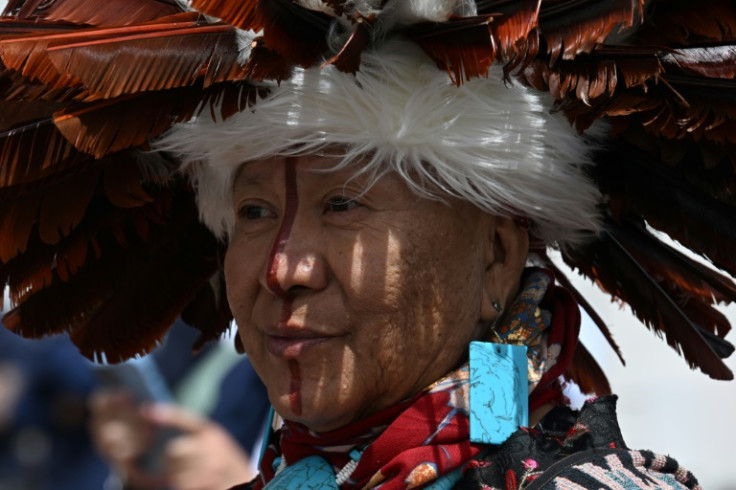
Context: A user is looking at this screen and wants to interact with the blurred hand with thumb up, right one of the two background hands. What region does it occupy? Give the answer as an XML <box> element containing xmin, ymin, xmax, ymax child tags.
<box><xmin>142</xmin><ymin>404</ymin><xmax>256</xmax><ymax>490</ymax></box>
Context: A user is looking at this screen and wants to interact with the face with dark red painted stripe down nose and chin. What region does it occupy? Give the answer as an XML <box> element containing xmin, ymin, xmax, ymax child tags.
<box><xmin>225</xmin><ymin>156</ymin><xmax>494</xmax><ymax>431</ymax></box>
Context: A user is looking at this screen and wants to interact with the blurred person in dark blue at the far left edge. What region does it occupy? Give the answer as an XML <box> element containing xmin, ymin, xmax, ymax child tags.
<box><xmin>0</xmin><ymin>325</ymin><xmax>107</xmax><ymax>490</ymax></box>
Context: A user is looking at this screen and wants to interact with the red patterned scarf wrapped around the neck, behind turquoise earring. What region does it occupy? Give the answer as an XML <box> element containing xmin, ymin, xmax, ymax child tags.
<box><xmin>254</xmin><ymin>268</ymin><xmax>580</xmax><ymax>490</ymax></box>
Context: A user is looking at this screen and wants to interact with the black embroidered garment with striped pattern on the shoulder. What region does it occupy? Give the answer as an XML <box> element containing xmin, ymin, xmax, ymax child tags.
<box><xmin>455</xmin><ymin>395</ymin><xmax>700</xmax><ymax>490</ymax></box>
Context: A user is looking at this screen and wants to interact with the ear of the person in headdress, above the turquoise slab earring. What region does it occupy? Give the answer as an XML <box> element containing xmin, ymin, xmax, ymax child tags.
<box><xmin>480</xmin><ymin>216</ymin><xmax>529</xmax><ymax>323</ymax></box>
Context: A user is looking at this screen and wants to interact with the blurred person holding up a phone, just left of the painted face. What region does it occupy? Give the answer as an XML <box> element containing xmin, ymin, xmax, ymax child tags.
<box><xmin>90</xmin><ymin>322</ymin><xmax>268</xmax><ymax>490</ymax></box>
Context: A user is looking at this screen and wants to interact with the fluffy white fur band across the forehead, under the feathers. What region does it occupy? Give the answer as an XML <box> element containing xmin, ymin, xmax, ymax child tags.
<box><xmin>158</xmin><ymin>39</ymin><xmax>599</xmax><ymax>244</ymax></box>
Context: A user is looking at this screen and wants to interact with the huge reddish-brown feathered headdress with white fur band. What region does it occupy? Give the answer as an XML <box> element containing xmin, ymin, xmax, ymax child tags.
<box><xmin>0</xmin><ymin>0</ymin><xmax>736</xmax><ymax>393</ymax></box>
